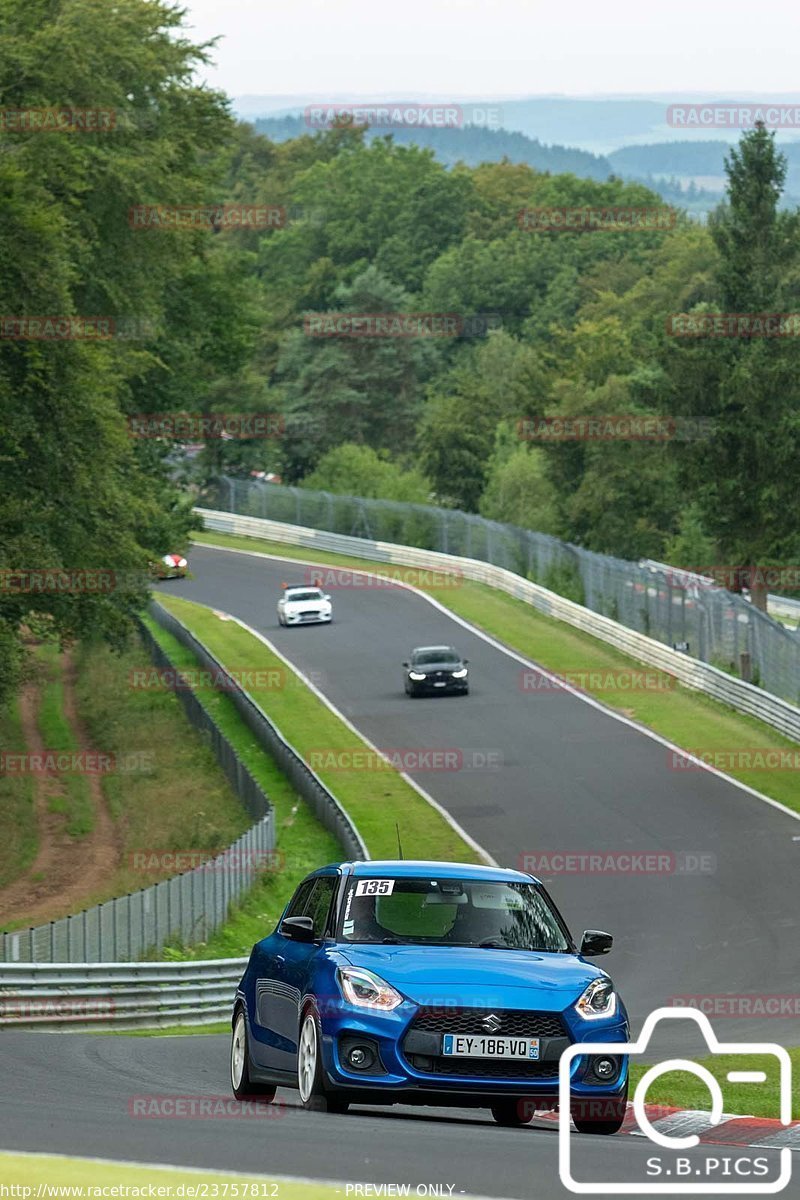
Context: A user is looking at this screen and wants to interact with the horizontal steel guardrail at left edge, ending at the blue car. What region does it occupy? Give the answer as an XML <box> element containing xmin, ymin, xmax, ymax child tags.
<box><xmin>0</xmin><ymin>959</ymin><xmax>247</xmax><ymax>1032</ymax></box>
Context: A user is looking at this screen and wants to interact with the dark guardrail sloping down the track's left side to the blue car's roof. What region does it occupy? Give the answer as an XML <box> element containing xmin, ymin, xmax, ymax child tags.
<box><xmin>150</xmin><ymin>601</ymin><xmax>369</xmax><ymax>859</ymax></box>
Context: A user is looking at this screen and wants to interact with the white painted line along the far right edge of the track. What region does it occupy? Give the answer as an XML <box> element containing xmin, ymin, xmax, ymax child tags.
<box><xmin>193</xmin><ymin>541</ymin><xmax>800</xmax><ymax>821</ymax></box>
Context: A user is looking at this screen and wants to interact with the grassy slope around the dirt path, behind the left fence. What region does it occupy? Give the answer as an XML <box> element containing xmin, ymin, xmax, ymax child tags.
<box><xmin>0</xmin><ymin>636</ymin><xmax>253</xmax><ymax>931</ymax></box>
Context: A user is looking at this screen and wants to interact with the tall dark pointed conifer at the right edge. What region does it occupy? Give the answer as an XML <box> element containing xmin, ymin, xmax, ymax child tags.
<box><xmin>667</xmin><ymin>125</ymin><xmax>800</xmax><ymax>611</ymax></box>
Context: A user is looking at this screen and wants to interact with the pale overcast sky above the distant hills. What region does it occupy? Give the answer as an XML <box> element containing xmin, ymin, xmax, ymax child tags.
<box><xmin>185</xmin><ymin>0</ymin><xmax>800</xmax><ymax>98</ymax></box>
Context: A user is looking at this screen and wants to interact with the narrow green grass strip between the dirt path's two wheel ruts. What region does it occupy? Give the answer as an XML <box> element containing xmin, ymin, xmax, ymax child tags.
<box><xmin>36</xmin><ymin>642</ymin><xmax>95</xmax><ymax>840</ymax></box>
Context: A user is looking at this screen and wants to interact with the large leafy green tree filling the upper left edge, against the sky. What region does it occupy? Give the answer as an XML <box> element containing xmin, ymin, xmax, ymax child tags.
<box><xmin>0</xmin><ymin>0</ymin><xmax>231</xmax><ymax>703</ymax></box>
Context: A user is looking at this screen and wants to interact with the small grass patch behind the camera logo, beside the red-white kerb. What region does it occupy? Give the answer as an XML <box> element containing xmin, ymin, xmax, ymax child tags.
<box><xmin>630</xmin><ymin>1049</ymin><xmax>800</xmax><ymax>1121</ymax></box>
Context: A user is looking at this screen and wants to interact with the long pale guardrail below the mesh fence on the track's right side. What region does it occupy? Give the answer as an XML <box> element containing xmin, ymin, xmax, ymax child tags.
<box><xmin>194</xmin><ymin>508</ymin><xmax>800</xmax><ymax>742</ymax></box>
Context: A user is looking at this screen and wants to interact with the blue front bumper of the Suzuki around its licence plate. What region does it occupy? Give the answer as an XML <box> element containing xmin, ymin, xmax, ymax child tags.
<box><xmin>320</xmin><ymin>1002</ymin><xmax>628</xmax><ymax>1105</ymax></box>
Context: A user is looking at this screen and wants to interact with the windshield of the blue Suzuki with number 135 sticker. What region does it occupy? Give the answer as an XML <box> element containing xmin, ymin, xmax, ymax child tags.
<box><xmin>339</xmin><ymin>877</ymin><xmax>571</xmax><ymax>952</ymax></box>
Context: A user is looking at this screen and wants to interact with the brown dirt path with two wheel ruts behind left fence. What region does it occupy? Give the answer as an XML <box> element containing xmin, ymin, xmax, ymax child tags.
<box><xmin>0</xmin><ymin>653</ymin><xmax>120</xmax><ymax>928</ymax></box>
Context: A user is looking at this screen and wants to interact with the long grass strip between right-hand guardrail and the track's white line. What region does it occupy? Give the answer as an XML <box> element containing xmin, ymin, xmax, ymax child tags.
<box><xmin>194</xmin><ymin>533</ymin><xmax>800</xmax><ymax>812</ymax></box>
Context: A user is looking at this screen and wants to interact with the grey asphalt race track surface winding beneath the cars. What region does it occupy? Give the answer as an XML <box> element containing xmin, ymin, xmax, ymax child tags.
<box><xmin>0</xmin><ymin>546</ymin><xmax>800</xmax><ymax>1200</ymax></box>
